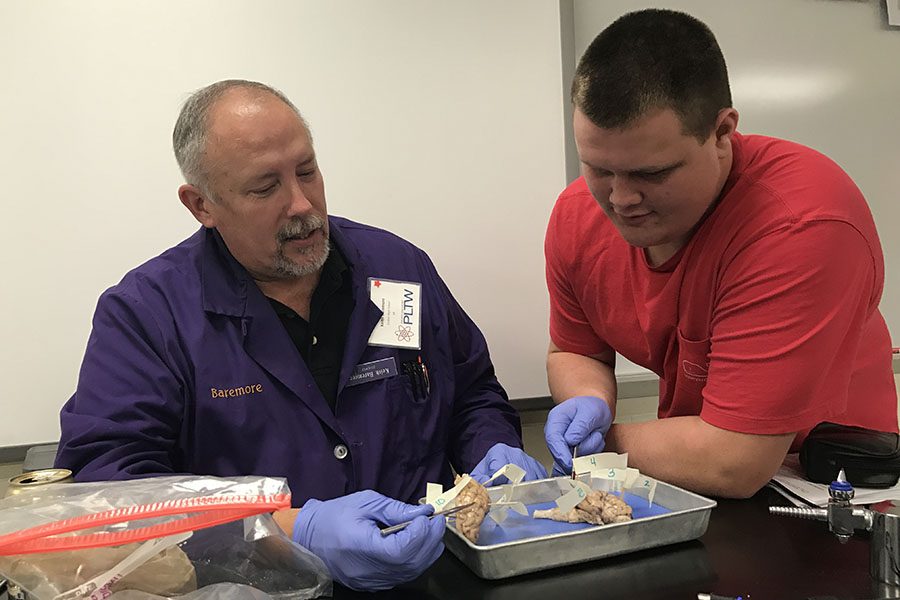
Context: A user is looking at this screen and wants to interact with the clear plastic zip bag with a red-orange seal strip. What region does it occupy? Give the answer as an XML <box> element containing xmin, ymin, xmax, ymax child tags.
<box><xmin>0</xmin><ymin>476</ymin><xmax>331</xmax><ymax>600</ymax></box>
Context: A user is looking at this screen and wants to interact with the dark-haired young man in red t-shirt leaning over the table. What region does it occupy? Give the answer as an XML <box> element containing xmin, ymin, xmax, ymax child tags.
<box><xmin>545</xmin><ymin>9</ymin><xmax>897</xmax><ymax>497</ymax></box>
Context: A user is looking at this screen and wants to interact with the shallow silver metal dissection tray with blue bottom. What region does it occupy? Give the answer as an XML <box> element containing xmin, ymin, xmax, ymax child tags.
<box><xmin>444</xmin><ymin>478</ymin><xmax>716</xmax><ymax>579</ymax></box>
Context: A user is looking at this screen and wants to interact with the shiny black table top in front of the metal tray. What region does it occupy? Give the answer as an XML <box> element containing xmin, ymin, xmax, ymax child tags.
<box><xmin>335</xmin><ymin>488</ymin><xmax>900</xmax><ymax>600</ymax></box>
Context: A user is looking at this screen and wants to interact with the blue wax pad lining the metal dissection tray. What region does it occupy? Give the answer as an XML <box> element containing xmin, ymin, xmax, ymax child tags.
<box><xmin>477</xmin><ymin>492</ymin><xmax>672</xmax><ymax>546</ymax></box>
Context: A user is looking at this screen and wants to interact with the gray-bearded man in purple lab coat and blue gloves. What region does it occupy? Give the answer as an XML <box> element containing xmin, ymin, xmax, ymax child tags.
<box><xmin>56</xmin><ymin>80</ymin><xmax>546</xmax><ymax>589</ymax></box>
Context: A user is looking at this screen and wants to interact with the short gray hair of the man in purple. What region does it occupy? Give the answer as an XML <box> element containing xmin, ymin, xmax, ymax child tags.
<box><xmin>172</xmin><ymin>79</ymin><xmax>312</xmax><ymax>195</ymax></box>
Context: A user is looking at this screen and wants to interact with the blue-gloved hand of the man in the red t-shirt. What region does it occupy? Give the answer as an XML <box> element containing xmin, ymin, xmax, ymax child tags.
<box><xmin>544</xmin><ymin>396</ymin><xmax>612</xmax><ymax>476</ymax></box>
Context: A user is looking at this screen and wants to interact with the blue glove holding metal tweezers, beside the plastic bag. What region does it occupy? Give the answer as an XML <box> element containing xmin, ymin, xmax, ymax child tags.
<box><xmin>293</xmin><ymin>490</ymin><xmax>445</xmax><ymax>591</ymax></box>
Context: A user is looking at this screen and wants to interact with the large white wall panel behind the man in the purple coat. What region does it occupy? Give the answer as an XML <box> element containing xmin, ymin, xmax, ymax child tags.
<box><xmin>0</xmin><ymin>0</ymin><xmax>565</xmax><ymax>446</ymax></box>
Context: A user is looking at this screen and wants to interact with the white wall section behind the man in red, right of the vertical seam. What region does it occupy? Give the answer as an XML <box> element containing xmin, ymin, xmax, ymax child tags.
<box><xmin>574</xmin><ymin>0</ymin><xmax>900</xmax><ymax>346</ymax></box>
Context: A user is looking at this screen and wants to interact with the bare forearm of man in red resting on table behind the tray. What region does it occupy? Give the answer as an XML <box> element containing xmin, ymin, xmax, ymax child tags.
<box><xmin>606</xmin><ymin>416</ymin><xmax>794</xmax><ymax>498</ymax></box>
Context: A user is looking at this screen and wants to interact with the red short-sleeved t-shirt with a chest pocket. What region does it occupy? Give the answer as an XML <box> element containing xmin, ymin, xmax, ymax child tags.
<box><xmin>544</xmin><ymin>135</ymin><xmax>897</xmax><ymax>449</ymax></box>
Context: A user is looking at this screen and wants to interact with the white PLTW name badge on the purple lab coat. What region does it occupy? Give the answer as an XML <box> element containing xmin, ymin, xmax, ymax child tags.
<box><xmin>369</xmin><ymin>277</ymin><xmax>422</xmax><ymax>350</ymax></box>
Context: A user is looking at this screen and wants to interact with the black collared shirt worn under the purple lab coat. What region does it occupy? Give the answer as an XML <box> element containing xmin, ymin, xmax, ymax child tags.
<box><xmin>269</xmin><ymin>244</ymin><xmax>353</xmax><ymax>410</ymax></box>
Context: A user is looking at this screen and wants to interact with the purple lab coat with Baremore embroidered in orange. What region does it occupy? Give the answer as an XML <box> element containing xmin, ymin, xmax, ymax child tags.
<box><xmin>56</xmin><ymin>217</ymin><xmax>522</xmax><ymax>506</ymax></box>
